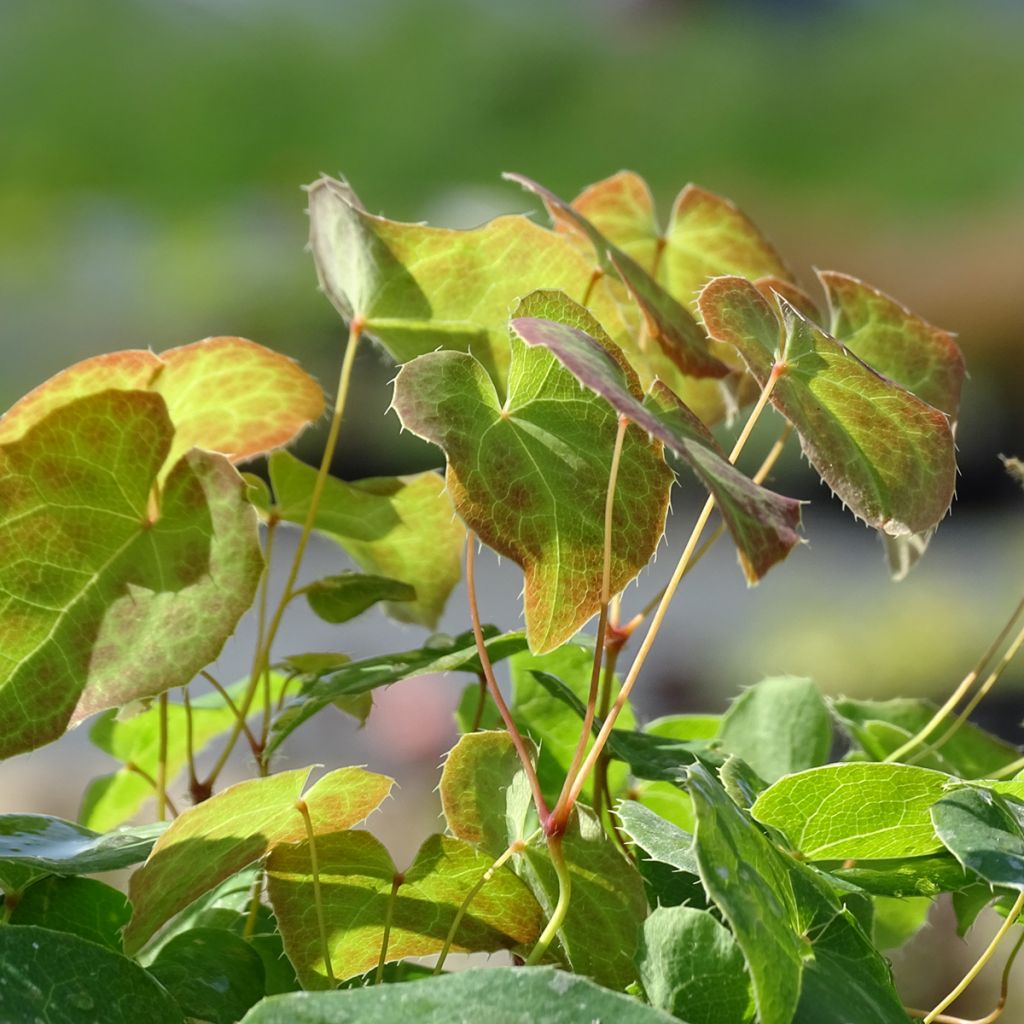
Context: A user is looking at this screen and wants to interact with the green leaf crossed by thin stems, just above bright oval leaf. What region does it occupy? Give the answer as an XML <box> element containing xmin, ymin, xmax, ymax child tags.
<box><xmin>831</xmin><ymin>697</ymin><xmax>1020</xmax><ymax>778</ymax></box>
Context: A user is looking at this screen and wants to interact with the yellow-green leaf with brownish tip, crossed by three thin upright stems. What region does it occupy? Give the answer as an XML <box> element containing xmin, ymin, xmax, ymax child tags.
<box><xmin>267</xmin><ymin>831</ymin><xmax>545</xmax><ymax>989</ymax></box>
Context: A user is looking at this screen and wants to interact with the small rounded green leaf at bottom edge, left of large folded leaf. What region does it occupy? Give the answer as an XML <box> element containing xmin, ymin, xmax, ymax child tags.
<box><xmin>637</xmin><ymin>906</ymin><xmax>751</xmax><ymax>1024</ymax></box>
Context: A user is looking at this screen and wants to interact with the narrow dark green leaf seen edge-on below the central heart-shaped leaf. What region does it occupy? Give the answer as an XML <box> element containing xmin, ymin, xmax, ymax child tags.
<box><xmin>264</xmin><ymin>626</ymin><xmax>526</xmax><ymax>758</ymax></box>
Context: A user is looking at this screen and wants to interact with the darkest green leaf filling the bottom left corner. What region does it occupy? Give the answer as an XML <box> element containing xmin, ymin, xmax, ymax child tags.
<box><xmin>0</xmin><ymin>925</ymin><xmax>183</xmax><ymax>1024</ymax></box>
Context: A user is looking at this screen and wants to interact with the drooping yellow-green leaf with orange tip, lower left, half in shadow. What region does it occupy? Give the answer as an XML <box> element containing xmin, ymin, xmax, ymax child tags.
<box><xmin>124</xmin><ymin>768</ymin><xmax>393</xmax><ymax>953</ymax></box>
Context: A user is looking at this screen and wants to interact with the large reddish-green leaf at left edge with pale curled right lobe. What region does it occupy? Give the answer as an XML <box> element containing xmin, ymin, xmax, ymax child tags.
<box><xmin>0</xmin><ymin>391</ymin><xmax>263</xmax><ymax>757</ymax></box>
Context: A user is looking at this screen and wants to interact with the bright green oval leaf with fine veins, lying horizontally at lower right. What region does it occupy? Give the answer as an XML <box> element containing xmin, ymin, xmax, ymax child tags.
<box><xmin>752</xmin><ymin>762</ymin><xmax>950</xmax><ymax>860</ymax></box>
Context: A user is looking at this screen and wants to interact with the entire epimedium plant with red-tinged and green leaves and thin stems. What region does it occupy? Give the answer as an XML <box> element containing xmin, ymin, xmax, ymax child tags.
<box><xmin>0</xmin><ymin>172</ymin><xmax>1024</xmax><ymax>1024</ymax></box>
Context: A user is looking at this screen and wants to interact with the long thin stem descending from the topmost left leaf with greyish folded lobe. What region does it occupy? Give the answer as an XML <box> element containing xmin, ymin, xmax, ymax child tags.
<box><xmin>205</xmin><ymin>316</ymin><xmax>365</xmax><ymax>787</ymax></box>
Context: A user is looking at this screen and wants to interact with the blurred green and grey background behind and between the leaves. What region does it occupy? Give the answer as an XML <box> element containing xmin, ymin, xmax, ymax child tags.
<box><xmin>0</xmin><ymin>0</ymin><xmax>1024</xmax><ymax>1012</ymax></box>
